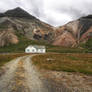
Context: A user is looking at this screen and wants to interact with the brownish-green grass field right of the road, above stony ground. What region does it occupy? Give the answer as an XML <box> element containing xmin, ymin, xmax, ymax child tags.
<box><xmin>32</xmin><ymin>53</ymin><xmax>92</xmax><ymax>75</ymax></box>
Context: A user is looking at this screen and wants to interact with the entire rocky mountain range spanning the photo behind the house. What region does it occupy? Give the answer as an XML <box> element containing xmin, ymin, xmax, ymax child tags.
<box><xmin>0</xmin><ymin>7</ymin><xmax>92</xmax><ymax>47</ymax></box>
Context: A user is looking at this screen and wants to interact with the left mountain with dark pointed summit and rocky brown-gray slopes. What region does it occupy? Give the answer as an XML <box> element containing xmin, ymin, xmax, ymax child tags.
<box><xmin>0</xmin><ymin>7</ymin><xmax>54</xmax><ymax>46</ymax></box>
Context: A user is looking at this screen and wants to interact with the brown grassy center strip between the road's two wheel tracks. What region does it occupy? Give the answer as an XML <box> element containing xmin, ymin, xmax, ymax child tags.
<box><xmin>11</xmin><ymin>59</ymin><xmax>30</xmax><ymax>92</ymax></box>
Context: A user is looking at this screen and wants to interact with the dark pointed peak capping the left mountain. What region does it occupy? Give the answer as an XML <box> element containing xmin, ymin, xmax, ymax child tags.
<box><xmin>0</xmin><ymin>7</ymin><xmax>35</xmax><ymax>19</ymax></box>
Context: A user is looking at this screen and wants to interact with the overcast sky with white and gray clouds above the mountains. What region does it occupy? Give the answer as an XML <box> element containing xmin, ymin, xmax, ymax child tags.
<box><xmin>0</xmin><ymin>0</ymin><xmax>92</xmax><ymax>26</ymax></box>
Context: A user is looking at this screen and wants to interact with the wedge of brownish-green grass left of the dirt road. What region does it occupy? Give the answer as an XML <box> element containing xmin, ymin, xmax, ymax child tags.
<box><xmin>0</xmin><ymin>53</ymin><xmax>27</xmax><ymax>67</ymax></box>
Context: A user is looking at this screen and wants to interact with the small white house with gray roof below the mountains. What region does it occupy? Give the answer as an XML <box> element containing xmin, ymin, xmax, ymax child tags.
<box><xmin>25</xmin><ymin>45</ymin><xmax>46</xmax><ymax>53</ymax></box>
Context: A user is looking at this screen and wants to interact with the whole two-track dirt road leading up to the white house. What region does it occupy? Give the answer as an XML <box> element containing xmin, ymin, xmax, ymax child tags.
<box><xmin>0</xmin><ymin>56</ymin><xmax>71</xmax><ymax>92</ymax></box>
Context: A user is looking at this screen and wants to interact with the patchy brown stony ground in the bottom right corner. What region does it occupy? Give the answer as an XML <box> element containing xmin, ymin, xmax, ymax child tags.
<box><xmin>41</xmin><ymin>70</ymin><xmax>92</xmax><ymax>92</ymax></box>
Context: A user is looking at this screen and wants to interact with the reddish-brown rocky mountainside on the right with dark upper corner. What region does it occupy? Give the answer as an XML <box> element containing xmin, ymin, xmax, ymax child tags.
<box><xmin>53</xmin><ymin>15</ymin><xmax>92</xmax><ymax>47</ymax></box>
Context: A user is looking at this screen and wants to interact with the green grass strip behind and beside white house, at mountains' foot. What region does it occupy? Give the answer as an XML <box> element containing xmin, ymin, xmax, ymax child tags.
<box><xmin>0</xmin><ymin>35</ymin><xmax>86</xmax><ymax>53</ymax></box>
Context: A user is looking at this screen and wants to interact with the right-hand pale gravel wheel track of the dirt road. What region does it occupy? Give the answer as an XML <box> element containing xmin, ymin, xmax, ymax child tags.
<box><xmin>24</xmin><ymin>57</ymin><xmax>48</xmax><ymax>92</ymax></box>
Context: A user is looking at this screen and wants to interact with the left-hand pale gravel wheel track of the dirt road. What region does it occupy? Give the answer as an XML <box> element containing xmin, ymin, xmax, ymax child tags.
<box><xmin>0</xmin><ymin>58</ymin><xmax>21</xmax><ymax>92</ymax></box>
